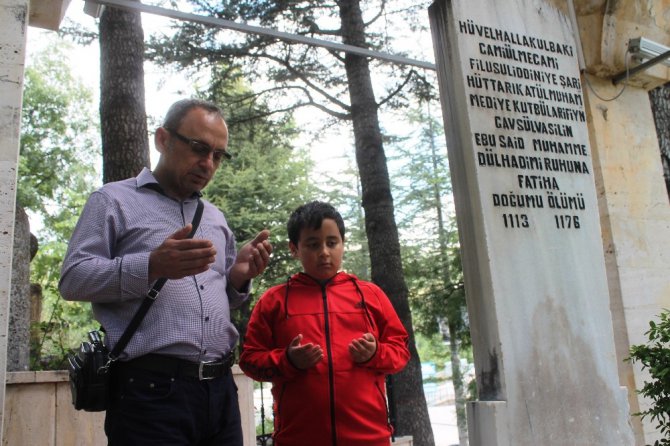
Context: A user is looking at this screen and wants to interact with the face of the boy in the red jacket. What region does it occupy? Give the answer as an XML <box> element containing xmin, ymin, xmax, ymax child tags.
<box><xmin>289</xmin><ymin>218</ymin><xmax>344</xmax><ymax>280</ymax></box>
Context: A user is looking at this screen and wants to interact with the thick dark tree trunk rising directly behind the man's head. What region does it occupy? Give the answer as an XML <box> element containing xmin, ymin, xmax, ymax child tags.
<box><xmin>100</xmin><ymin>2</ymin><xmax>150</xmax><ymax>183</ymax></box>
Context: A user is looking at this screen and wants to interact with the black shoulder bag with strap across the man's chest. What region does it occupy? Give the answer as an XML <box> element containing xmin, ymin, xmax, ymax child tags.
<box><xmin>67</xmin><ymin>200</ymin><xmax>204</xmax><ymax>412</ymax></box>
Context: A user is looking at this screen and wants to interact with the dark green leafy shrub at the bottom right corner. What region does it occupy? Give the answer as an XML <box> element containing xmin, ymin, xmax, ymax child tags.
<box><xmin>628</xmin><ymin>310</ymin><xmax>670</xmax><ymax>446</ymax></box>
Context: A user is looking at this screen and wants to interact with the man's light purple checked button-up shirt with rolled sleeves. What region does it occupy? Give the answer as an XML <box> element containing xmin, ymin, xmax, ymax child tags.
<box><xmin>59</xmin><ymin>168</ymin><xmax>248</xmax><ymax>361</ymax></box>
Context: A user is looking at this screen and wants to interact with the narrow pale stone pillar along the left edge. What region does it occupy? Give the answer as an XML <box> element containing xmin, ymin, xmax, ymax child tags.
<box><xmin>0</xmin><ymin>0</ymin><xmax>28</xmax><ymax>443</ymax></box>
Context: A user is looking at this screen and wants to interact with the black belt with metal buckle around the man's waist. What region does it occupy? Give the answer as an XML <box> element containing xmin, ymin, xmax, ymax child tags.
<box><xmin>116</xmin><ymin>352</ymin><xmax>235</xmax><ymax>380</ymax></box>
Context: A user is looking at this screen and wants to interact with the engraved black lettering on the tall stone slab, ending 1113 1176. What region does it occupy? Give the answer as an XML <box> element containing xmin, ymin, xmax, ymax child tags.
<box><xmin>458</xmin><ymin>19</ymin><xmax>593</xmax><ymax>231</ymax></box>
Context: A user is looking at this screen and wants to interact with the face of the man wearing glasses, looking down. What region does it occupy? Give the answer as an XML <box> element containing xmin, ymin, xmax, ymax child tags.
<box><xmin>154</xmin><ymin>108</ymin><xmax>228</xmax><ymax>200</ymax></box>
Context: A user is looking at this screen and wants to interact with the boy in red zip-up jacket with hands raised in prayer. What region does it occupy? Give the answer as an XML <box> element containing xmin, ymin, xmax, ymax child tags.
<box><xmin>240</xmin><ymin>201</ymin><xmax>409</xmax><ymax>446</ymax></box>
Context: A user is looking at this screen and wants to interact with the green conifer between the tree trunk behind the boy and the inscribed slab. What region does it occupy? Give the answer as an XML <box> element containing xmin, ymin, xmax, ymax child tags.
<box><xmin>393</xmin><ymin>104</ymin><xmax>471</xmax><ymax>444</ymax></box>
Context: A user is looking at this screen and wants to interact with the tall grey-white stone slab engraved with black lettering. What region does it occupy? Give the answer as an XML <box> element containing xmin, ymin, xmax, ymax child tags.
<box><xmin>430</xmin><ymin>0</ymin><xmax>634</xmax><ymax>446</ymax></box>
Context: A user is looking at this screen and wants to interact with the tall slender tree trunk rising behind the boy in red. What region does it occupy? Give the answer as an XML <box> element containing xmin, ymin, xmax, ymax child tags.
<box><xmin>339</xmin><ymin>0</ymin><xmax>435</xmax><ymax>446</ymax></box>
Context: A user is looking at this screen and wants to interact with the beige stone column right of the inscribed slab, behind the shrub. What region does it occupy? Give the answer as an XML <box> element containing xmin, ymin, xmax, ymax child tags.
<box><xmin>586</xmin><ymin>76</ymin><xmax>670</xmax><ymax>445</ymax></box>
